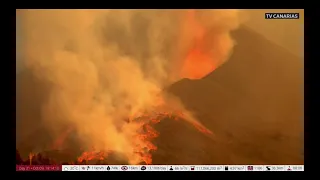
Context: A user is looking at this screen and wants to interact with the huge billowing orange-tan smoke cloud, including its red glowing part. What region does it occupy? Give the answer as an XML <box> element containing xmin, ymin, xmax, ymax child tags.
<box><xmin>17</xmin><ymin>10</ymin><xmax>244</xmax><ymax>163</ymax></box>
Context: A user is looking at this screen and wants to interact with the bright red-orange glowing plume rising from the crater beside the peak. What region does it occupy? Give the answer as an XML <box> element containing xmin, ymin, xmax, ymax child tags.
<box><xmin>180</xmin><ymin>10</ymin><xmax>240</xmax><ymax>79</ymax></box>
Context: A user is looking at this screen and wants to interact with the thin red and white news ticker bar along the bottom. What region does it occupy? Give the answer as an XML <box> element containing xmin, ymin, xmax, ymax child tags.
<box><xmin>16</xmin><ymin>165</ymin><xmax>304</xmax><ymax>171</ymax></box>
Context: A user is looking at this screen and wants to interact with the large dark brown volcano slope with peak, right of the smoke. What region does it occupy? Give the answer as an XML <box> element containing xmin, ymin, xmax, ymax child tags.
<box><xmin>164</xmin><ymin>27</ymin><xmax>303</xmax><ymax>164</ymax></box>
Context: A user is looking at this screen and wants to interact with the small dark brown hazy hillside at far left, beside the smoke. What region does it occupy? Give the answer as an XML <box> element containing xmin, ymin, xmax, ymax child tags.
<box><xmin>16</xmin><ymin>69</ymin><xmax>49</xmax><ymax>158</ymax></box>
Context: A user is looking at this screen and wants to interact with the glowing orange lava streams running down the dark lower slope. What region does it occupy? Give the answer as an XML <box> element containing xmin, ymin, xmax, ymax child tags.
<box><xmin>20</xmin><ymin>107</ymin><xmax>212</xmax><ymax>164</ymax></box>
